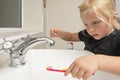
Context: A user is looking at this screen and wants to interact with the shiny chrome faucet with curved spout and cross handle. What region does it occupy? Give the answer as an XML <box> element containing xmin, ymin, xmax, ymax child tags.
<box><xmin>3</xmin><ymin>37</ymin><xmax>55</xmax><ymax>67</ymax></box>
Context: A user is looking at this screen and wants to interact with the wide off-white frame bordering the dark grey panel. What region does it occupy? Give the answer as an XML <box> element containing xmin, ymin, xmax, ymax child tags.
<box><xmin>0</xmin><ymin>0</ymin><xmax>43</xmax><ymax>32</ymax></box>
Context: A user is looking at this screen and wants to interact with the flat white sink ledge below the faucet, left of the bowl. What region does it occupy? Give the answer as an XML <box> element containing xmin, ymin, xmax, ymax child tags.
<box><xmin>0</xmin><ymin>64</ymin><xmax>34</xmax><ymax>80</ymax></box>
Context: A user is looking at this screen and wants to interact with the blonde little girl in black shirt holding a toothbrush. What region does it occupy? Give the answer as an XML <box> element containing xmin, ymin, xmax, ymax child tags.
<box><xmin>50</xmin><ymin>0</ymin><xmax>120</xmax><ymax>80</ymax></box>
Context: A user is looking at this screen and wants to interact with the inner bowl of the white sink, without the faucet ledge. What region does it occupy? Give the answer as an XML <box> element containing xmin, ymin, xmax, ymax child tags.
<box><xmin>26</xmin><ymin>49</ymin><xmax>84</xmax><ymax>80</ymax></box>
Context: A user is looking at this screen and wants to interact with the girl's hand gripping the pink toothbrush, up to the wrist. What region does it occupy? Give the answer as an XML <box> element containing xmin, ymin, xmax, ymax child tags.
<box><xmin>65</xmin><ymin>55</ymin><xmax>98</xmax><ymax>80</ymax></box>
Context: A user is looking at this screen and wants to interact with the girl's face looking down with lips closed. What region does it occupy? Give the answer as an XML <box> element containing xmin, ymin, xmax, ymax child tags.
<box><xmin>81</xmin><ymin>10</ymin><xmax>113</xmax><ymax>40</ymax></box>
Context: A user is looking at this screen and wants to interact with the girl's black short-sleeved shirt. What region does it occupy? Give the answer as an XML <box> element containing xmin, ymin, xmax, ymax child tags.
<box><xmin>78</xmin><ymin>30</ymin><xmax>120</xmax><ymax>56</ymax></box>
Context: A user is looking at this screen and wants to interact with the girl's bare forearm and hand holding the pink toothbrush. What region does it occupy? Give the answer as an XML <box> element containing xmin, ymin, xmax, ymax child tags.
<box><xmin>65</xmin><ymin>55</ymin><xmax>120</xmax><ymax>80</ymax></box>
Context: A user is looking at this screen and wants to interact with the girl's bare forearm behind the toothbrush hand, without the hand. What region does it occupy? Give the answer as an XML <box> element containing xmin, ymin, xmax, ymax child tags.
<box><xmin>96</xmin><ymin>55</ymin><xmax>120</xmax><ymax>75</ymax></box>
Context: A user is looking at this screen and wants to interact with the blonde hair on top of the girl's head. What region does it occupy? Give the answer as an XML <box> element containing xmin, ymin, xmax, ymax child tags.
<box><xmin>78</xmin><ymin>0</ymin><xmax>116</xmax><ymax>24</ymax></box>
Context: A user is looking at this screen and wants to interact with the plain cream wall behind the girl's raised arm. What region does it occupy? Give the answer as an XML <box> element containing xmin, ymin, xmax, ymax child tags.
<box><xmin>46</xmin><ymin>0</ymin><xmax>84</xmax><ymax>49</ymax></box>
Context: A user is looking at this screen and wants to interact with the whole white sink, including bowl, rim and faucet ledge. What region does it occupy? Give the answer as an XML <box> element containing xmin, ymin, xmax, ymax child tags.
<box><xmin>0</xmin><ymin>49</ymin><xmax>120</xmax><ymax>80</ymax></box>
